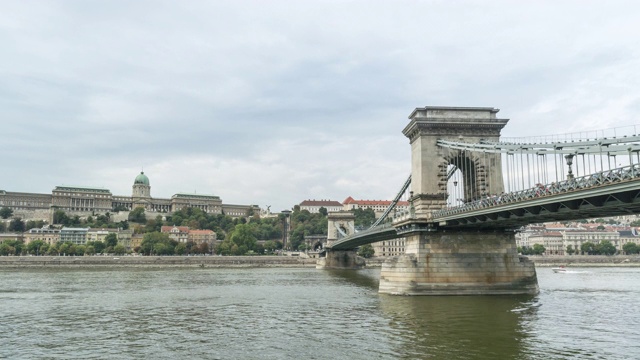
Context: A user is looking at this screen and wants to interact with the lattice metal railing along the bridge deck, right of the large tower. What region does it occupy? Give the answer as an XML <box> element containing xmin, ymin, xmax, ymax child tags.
<box><xmin>432</xmin><ymin>164</ymin><xmax>640</xmax><ymax>218</ymax></box>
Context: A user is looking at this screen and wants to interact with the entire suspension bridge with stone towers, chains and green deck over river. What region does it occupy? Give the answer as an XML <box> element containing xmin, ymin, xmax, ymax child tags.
<box><xmin>320</xmin><ymin>106</ymin><xmax>640</xmax><ymax>295</ymax></box>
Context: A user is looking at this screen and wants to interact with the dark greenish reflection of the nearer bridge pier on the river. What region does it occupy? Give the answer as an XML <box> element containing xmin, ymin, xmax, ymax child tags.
<box><xmin>380</xmin><ymin>295</ymin><xmax>536</xmax><ymax>359</ymax></box>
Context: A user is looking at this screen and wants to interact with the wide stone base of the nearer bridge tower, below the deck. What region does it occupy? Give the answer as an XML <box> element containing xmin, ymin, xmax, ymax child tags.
<box><xmin>379</xmin><ymin>231</ymin><xmax>538</xmax><ymax>295</ymax></box>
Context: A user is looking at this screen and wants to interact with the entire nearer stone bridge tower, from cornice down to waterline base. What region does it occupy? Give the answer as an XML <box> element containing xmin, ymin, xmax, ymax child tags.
<box><xmin>380</xmin><ymin>107</ymin><xmax>538</xmax><ymax>295</ymax></box>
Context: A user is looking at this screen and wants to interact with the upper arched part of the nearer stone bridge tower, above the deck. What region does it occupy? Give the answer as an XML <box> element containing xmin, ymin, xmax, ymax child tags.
<box><xmin>402</xmin><ymin>106</ymin><xmax>509</xmax><ymax>220</ymax></box>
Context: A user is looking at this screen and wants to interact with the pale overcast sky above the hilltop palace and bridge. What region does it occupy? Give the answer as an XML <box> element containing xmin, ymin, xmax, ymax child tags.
<box><xmin>0</xmin><ymin>0</ymin><xmax>640</xmax><ymax>211</ymax></box>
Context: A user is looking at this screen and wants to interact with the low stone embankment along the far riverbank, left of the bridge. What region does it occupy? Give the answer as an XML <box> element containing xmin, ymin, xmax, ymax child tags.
<box><xmin>0</xmin><ymin>256</ymin><xmax>316</xmax><ymax>268</ymax></box>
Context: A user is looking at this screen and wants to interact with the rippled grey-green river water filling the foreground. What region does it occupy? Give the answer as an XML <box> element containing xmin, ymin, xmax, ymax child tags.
<box><xmin>0</xmin><ymin>268</ymin><xmax>640</xmax><ymax>360</ymax></box>
